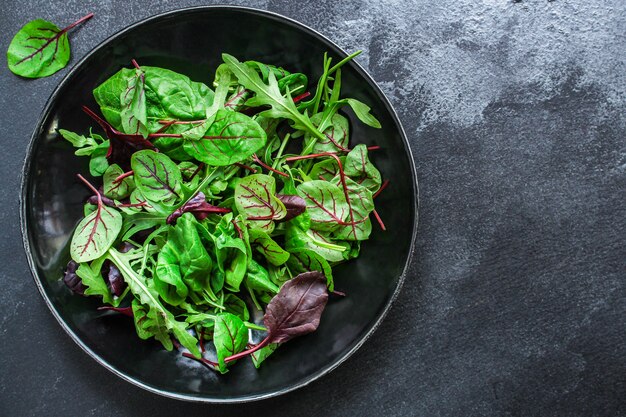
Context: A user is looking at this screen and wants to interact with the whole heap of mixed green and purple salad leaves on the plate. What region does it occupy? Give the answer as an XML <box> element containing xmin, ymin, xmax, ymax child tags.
<box><xmin>59</xmin><ymin>53</ymin><xmax>387</xmax><ymax>373</ymax></box>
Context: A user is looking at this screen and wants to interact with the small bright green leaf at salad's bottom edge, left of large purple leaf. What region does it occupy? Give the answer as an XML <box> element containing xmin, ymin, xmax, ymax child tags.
<box><xmin>213</xmin><ymin>313</ymin><xmax>248</xmax><ymax>373</ymax></box>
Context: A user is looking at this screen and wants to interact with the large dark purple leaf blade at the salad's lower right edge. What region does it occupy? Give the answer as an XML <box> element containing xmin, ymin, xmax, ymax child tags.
<box><xmin>263</xmin><ymin>271</ymin><xmax>328</xmax><ymax>343</ymax></box>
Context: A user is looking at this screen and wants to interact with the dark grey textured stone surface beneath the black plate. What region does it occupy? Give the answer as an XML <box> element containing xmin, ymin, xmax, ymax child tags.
<box><xmin>0</xmin><ymin>0</ymin><xmax>626</xmax><ymax>416</ymax></box>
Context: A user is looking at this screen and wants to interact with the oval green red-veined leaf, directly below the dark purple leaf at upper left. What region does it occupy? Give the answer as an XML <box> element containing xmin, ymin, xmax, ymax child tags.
<box><xmin>130</xmin><ymin>149</ymin><xmax>183</xmax><ymax>203</ymax></box>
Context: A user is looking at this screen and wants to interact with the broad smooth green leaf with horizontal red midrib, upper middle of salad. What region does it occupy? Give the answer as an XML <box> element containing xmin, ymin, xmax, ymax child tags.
<box><xmin>184</xmin><ymin>109</ymin><xmax>267</xmax><ymax>166</ymax></box>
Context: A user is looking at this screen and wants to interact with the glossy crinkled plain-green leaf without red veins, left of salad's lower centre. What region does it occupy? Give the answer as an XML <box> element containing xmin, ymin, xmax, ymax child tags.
<box><xmin>154</xmin><ymin>213</ymin><xmax>212</xmax><ymax>305</ymax></box>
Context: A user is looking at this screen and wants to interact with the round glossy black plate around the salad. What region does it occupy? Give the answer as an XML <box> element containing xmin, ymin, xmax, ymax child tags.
<box><xmin>21</xmin><ymin>7</ymin><xmax>417</xmax><ymax>402</ymax></box>
